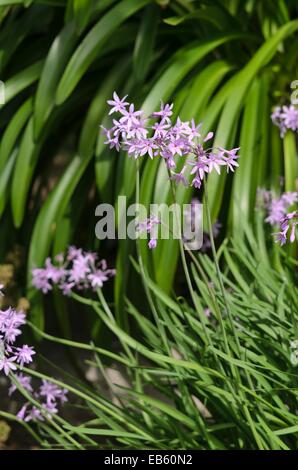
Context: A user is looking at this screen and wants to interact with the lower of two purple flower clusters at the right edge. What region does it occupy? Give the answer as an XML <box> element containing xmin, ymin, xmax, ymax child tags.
<box><xmin>258</xmin><ymin>189</ymin><xmax>298</xmax><ymax>245</ymax></box>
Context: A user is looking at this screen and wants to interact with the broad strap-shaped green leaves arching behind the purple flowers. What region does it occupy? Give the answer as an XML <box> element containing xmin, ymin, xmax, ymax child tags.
<box><xmin>0</xmin><ymin>0</ymin><xmax>298</xmax><ymax>326</ymax></box>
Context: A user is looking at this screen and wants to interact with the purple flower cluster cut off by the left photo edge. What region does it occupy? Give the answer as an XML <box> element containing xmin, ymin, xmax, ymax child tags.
<box><xmin>0</xmin><ymin>307</ymin><xmax>35</xmax><ymax>375</ymax></box>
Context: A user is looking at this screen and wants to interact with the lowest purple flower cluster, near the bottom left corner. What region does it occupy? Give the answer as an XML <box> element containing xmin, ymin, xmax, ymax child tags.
<box><xmin>8</xmin><ymin>373</ymin><xmax>67</xmax><ymax>422</ymax></box>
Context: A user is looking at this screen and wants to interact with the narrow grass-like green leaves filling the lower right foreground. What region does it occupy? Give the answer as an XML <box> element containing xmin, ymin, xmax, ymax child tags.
<box><xmin>9</xmin><ymin>222</ymin><xmax>298</xmax><ymax>450</ymax></box>
